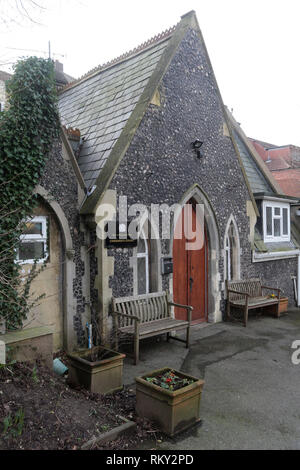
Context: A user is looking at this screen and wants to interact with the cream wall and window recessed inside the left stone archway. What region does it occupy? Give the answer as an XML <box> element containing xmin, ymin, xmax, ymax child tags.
<box><xmin>18</xmin><ymin>197</ymin><xmax>63</xmax><ymax>351</ymax></box>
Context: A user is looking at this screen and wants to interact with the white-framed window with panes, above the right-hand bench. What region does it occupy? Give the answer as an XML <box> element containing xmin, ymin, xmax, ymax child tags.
<box><xmin>263</xmin><ymin>201</ymin><xmax>291</xmax><ymax>242</ymax></box>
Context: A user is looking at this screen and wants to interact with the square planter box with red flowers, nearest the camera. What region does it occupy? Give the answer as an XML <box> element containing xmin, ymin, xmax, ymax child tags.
<box><xmin>135</xmin><ymin>367</ymin><xmax>204</xmax><ymax>436</ymax></box>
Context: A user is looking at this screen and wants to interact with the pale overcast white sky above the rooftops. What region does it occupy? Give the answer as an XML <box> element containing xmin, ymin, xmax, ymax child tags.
<box><xmin>0</xmin><ymin>0</ymin><xmax>300</xmax><ymax>146</ymax></box>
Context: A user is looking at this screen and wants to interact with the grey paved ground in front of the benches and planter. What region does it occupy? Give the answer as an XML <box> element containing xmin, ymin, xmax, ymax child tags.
<box><xmin>124</xmin><ymin>309</ymin><xmax>300</xmax><ymax>450</ymax></box>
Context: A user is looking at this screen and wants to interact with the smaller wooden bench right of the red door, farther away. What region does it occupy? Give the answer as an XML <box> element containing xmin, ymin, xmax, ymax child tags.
<box><xmin>226</xmin><ymin>278</ymin><xmax>280</xmax><ymax>326</ymax></box>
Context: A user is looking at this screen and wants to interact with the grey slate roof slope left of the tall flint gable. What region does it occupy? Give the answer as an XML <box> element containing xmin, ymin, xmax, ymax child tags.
<box><xmin>59</xmin><ymin>28</ymin><xmax>174</xmax><ymax>187</ymax></box>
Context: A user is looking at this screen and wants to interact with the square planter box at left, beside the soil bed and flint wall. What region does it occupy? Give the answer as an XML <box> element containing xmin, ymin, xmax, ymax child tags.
<box><xmin>67</xmin><ymin>346</ymin><xmax>125</xmax><ymax>394</ymax></box>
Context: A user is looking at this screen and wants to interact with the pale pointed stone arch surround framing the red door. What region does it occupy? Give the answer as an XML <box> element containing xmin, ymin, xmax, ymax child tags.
<box><xmin>169</xmin><ymin>184</ymin><xmax>222</xmax><ymax>322</ymax></box>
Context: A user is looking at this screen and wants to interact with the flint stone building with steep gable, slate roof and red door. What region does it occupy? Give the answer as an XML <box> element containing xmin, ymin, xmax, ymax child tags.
<box><xmin>14</xmin><ymin>12</ymin><xmax>300</xmax><ymax>349</ymax></box>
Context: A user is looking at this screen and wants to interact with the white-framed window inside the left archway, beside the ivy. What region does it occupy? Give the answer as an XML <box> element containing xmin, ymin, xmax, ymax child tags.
<box><xmin>17</xmin><ymin>215</ymin><xmax>48</xmax><ymax>264</ymax></box>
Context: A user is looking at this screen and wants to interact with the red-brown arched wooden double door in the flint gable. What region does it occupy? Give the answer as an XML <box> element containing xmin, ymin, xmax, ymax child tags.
<box><xmin>173</xmin><ymin>201</ymin><xmax>208</xmax><ymax>322</ymax></box>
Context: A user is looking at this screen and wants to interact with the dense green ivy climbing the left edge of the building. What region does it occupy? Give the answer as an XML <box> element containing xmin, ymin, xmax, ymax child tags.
<box><xmin>0</xmin><ymin>57</ymin><xmax>59</xmax><ymax>327</ymax></box>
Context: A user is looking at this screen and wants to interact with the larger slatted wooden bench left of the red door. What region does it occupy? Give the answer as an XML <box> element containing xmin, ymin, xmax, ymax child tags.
<box><xmin>112</xmin><ymin>292</ymin><xmax>193</xmax><ymax>364</ymax></box>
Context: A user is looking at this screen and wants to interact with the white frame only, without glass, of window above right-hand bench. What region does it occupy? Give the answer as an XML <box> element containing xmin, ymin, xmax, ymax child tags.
<box><xmin>263</xmin><ymin>201</ymin><xmax>291</xmax><ymax>242</ymax></box>
